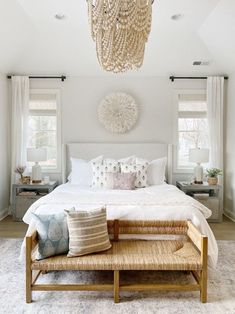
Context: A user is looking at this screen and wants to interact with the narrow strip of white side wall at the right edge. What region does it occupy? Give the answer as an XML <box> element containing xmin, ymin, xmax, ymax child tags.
<box><xmin>224</xmin><ymin>73</ymin><xmax>235</xmax><ymax>220</ymax></box>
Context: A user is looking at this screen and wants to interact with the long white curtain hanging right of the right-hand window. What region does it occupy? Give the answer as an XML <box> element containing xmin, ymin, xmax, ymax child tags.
<box><xmin>207</xmin><ymin>76</ymin><xmax>224</xmax><ymax>170</ymax></box>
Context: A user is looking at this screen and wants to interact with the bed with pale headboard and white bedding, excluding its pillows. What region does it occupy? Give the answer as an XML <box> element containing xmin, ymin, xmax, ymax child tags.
<box><xmin>23</xmin><ymin>143</ymin><xmax>218</xmax><ymax>268</ymax></box>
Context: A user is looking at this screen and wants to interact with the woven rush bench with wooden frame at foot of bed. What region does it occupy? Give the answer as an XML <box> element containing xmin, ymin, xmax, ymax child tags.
<box><xmin>26</xmin><ymin>220</ymin><xmax>208</xmax><ymax>303</ymax></box>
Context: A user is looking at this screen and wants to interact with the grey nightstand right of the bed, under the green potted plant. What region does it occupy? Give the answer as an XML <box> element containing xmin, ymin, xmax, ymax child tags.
<box><xmin>176</xmin><ymin>181</ymin><xmax>223</xmax><ymax>222</ymax></box>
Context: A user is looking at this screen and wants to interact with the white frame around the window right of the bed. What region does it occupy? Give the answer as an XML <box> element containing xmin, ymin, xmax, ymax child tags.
<box><xmin>173</xmin><ymin>89</ymin><xmax>206</xmax><ymax>174</ymax></box>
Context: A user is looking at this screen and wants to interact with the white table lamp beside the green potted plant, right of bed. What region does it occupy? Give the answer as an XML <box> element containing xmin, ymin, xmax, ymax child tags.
<box><xmin>189</xmin><ymin>148</ymin><xmax>209</xmax><ymax>184</ymax></box>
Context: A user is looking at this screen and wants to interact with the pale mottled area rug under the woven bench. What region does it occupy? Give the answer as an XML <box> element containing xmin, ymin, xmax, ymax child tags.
<box><xmin>0</xmin><ymin>239</ymin><xmax>235</xmax><ymax>314</ymax></box>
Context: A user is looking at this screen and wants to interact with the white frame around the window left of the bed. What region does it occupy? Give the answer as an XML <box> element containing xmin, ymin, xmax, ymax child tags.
<box><xmin>29</xmin><ymin>88</ymin><xmax>62</xmax><ymax>174</ymax></box>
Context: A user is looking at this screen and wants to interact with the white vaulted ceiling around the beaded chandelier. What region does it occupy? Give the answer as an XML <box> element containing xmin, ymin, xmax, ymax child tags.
<box><xmin>0</xmin><ymin>0</ymin><xmax>235</xmax><ymax>76</ymax></box>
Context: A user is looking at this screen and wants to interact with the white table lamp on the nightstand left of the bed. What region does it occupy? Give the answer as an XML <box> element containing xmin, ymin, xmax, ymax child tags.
<box><xmin>27</xmin><ymin>148</ymin><xmax>47</xmax><ymax>183</ymax></box>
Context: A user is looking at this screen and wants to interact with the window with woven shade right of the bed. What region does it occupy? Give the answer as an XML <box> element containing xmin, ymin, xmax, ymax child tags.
<box><xmin>175</xmin><ymin>92</ymin><xmax>209</xmax><ymax>170</ymax></box>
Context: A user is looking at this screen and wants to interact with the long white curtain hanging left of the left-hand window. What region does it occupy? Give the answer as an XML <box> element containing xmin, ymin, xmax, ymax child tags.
<box><xmin>11</xmin><ymin>76</ymin><xmax>29</xmax><ymax>184</ymax></box>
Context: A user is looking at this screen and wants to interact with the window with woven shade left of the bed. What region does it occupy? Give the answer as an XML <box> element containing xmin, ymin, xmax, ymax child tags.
<box><xmin>28</xmin><ymin>90</ymin><xmax>61</xmax><ymax>172</ymax></box>
